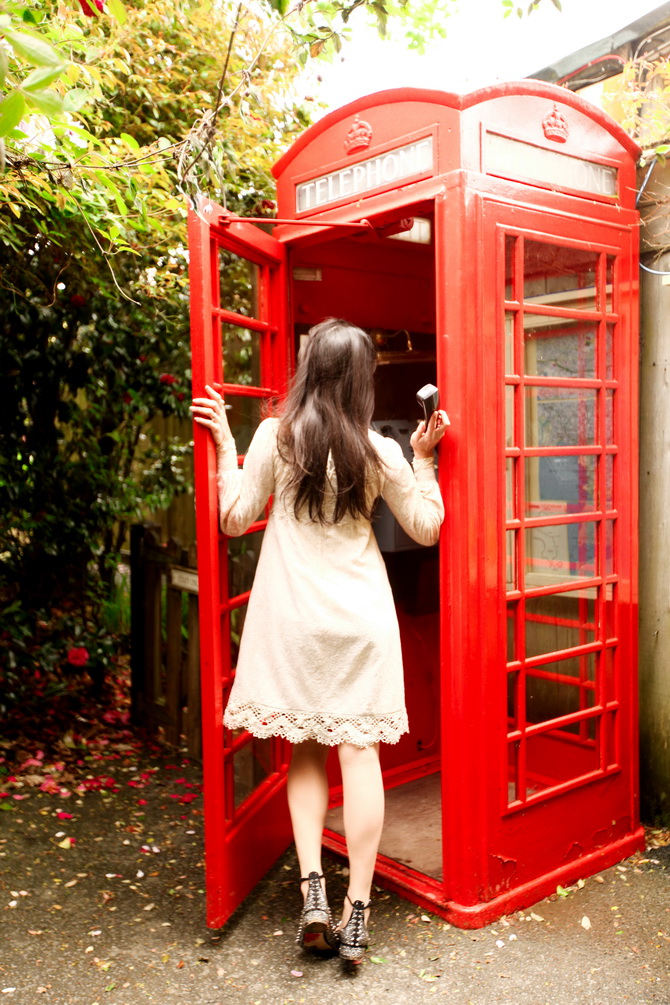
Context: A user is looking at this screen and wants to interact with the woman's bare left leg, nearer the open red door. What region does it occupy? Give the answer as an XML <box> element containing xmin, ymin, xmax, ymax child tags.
<box><xmin>287</xmin><ymin>740</ymin><xmax>330</xmax><ymax>897</ymax></box>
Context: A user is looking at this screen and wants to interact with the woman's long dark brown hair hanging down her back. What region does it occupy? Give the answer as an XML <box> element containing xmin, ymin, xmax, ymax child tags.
<box><xmin>278</xmin><ymin>318</ymin><xmax>382</xmax><ymax>524</ymax></box>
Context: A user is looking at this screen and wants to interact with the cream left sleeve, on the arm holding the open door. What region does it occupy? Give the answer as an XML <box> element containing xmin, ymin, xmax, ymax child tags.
<box><xmin>217</xmin><ymin>419</ymin><xmax>276</xmax><ymax>538</ymax></box>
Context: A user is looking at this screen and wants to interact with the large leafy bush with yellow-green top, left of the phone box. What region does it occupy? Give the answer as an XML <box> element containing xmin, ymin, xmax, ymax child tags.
<box><xmin>0</xmin><ymin>0</ymin><xmax>306</xmax><ymax>635</ymax></box>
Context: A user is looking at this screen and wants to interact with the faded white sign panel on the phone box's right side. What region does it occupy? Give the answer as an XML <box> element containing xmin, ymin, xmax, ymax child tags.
<box><xmin>484</xmin><ymin>133</ymin><xmax>618</xmax><ymax>196</ymax></box>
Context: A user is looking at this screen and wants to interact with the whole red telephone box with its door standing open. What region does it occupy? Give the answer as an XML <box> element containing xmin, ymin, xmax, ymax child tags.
<box><xmin>191</xmin><ymin>81</ymin><xmax>643</xmax><ymax>928</ymax></box>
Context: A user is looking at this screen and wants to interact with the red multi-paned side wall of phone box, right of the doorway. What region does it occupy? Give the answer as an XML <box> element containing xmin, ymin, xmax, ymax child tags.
<box><xmin>476</xmin><ymin>195</ymin><xmax>639</xmax><ymax>904</ymax></box>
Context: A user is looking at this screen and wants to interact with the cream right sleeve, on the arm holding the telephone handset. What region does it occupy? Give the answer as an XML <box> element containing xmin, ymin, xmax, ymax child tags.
<box><xmin>382</xmin><ymin>438</ymin><xmax>444</xmax><ymax>545</ymax></box>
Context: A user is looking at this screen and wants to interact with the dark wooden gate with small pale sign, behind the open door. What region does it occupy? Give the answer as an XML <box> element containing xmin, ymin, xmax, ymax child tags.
<box><xmin>131</xmin><ymin>524</ymin><xmax>202</xmax><ymax>758</ymax></box>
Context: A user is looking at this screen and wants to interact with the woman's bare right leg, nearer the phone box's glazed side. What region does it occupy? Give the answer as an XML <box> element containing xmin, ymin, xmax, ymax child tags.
<box><xmin>338</xmin><ymin>744</ymin><xmax>384</xmax><ymax>925</ymax></box>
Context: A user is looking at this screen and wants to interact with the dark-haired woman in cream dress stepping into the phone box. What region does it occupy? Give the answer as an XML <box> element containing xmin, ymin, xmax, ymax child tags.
<box><xmin>192</xmin><ymin>319</ymin><xmax>446</xmax><ymax>962</ymax></box>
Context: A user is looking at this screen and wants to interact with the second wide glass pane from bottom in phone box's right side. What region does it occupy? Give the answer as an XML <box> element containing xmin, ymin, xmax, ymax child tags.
<box><xmin>525</xmin><ymin>653</ymin><xmax>595</xmax><ymax>734</ymax></box>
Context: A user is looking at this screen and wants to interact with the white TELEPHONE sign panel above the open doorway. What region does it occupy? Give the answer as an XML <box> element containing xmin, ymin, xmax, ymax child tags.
<box><xmin>295</xmin><ymin>136</ymin><xmax>433</xmax><ymax>213</ymax></box>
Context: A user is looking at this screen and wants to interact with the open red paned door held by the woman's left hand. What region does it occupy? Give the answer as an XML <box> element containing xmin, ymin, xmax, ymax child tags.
<box><xmin>189</xmin><ymin>200</ymin><xmax>290</xmax><ymax>928</ymax></box>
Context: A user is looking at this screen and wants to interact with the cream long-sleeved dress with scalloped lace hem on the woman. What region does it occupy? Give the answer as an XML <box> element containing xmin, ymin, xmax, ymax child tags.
<box><xmin>218</xmin><ymin>418</ymin><xmax>444</xmax><ymax>747</ymax></box>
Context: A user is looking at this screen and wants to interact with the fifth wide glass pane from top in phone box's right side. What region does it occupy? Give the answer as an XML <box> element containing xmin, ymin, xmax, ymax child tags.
<box><xmin>525</xmin><ymin>523</ymin><xmax>597</xmax><ymax>587</ymax></box>
